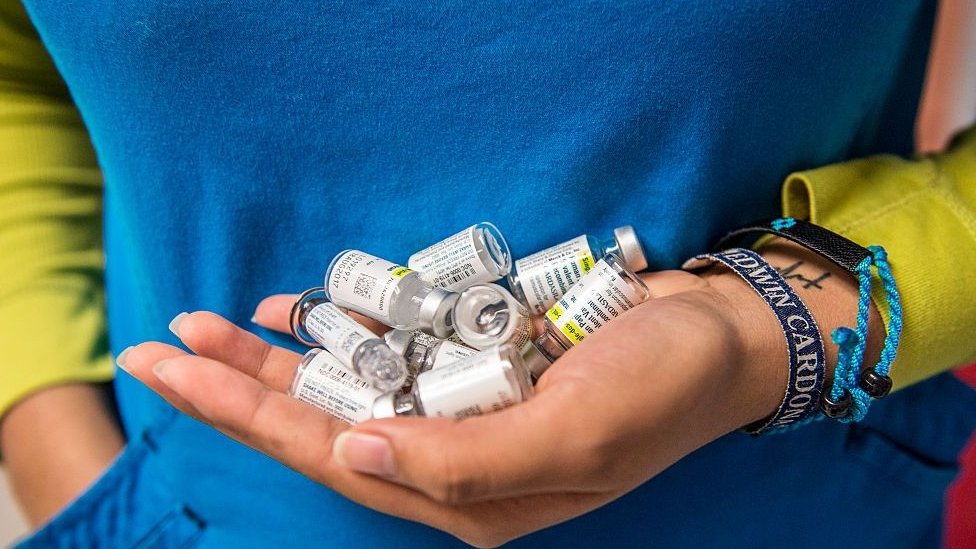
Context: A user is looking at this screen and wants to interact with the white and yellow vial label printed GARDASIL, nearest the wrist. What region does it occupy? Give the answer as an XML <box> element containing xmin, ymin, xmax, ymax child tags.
<box><xmin>546</xmin><ymin>260</ymin><xmax>644</xmax><ymax>345</ymax></box>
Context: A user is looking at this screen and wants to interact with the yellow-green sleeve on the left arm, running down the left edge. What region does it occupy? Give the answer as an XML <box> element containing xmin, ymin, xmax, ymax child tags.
<box><xmin>0</xmin><ymin>2</ymin><xmax>113</xmax><ymax>420</ymax></box>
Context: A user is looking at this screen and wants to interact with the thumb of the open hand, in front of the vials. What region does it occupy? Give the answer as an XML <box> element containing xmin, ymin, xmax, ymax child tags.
<box><xmin>333</xmin><ymin>384</ymin><xmax>596</xmax><ymax>504</ymax></box>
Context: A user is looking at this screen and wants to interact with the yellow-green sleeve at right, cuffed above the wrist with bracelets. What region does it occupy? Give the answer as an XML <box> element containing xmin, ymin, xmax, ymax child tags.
<box><xmin>783</xmin><ymin>127</ymin><xmax>976</xmax><ymax>388</ymax></box>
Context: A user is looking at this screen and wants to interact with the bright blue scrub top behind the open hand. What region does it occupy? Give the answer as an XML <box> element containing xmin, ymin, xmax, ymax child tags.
<box><xmin>13</xmin><ymin>0</ymin><xmax>976</xmax><ymax>548</ymax></box>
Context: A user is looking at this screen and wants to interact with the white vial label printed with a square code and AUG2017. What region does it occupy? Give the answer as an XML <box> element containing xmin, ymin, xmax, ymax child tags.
<box><xmin>329</xmin><ymin>250</ymin><xmax>413</xmax><ymax>325</ymax></box>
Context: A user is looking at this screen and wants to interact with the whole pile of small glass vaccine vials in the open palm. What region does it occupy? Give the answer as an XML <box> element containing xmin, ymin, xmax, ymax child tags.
<box><xmin>282</xmin><ymin>223</ymin><xmax>650</xmax><ymax>423</ymax></box>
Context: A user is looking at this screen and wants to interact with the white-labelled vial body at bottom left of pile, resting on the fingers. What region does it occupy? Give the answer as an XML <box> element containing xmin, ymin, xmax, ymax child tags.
<box><xmin>288</xmin><ymin>349</ymin><xmax>383</xmax><ymax>423</ymax></box>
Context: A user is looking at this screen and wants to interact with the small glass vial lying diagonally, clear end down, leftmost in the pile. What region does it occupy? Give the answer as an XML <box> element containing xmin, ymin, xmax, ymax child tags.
<box><xmin>291</xmin><ymin>288</ymin><xmax>407</xmax><ymax>391</ymax></box>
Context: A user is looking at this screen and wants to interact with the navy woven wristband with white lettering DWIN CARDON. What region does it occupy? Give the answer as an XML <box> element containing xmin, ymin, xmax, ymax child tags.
<box><xmin>682</xmin><ymin>248</ymin><xmax>826</xmax><ymax>435</ymax></box>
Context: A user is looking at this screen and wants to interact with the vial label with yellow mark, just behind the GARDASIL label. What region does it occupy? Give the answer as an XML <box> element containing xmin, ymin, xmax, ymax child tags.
<box><xmin>515</xmin><ymin>235</ymin><xmax>595</xmax><ymax>315</ymax></box>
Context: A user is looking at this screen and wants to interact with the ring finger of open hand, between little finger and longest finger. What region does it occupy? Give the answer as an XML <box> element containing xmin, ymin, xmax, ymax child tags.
<box><xmin>170</xmin><ymin>311</ymin><xmax>301</xmax><ymax>392</ymax></box>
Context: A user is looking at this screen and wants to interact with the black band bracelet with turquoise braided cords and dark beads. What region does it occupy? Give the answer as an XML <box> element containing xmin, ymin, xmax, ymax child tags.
<box><xmin>715</xmin><ymin>217</ymin><xmax>903</xmax><ymax>422</ymax></box>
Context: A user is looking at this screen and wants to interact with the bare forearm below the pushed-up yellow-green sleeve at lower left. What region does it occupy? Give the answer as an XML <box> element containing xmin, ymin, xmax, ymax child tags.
<box><xmin>0</xmin><ymin>384</ymin><xmax>124</xmax><ymax>526</ymax></box>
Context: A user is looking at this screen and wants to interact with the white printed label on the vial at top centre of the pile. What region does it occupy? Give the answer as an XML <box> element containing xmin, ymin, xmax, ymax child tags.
<box><xmin>407</xmin><ymin>226</ymin><xmax>498</xmax><ymax>290</ymax></box>
